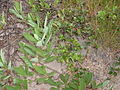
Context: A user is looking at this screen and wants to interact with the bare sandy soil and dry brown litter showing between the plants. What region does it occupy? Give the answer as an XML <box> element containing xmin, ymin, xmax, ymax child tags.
<box><xmin>0</xmin><ymin>0</ymin><xmax>120</xmax><ymax>90</ymax></box>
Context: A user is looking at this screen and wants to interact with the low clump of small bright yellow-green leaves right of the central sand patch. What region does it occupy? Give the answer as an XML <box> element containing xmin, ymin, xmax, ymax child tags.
<box><xmin>57</xmin><ymin>38</ymin><xmax>83</xmax><ymax>71</ymax></box>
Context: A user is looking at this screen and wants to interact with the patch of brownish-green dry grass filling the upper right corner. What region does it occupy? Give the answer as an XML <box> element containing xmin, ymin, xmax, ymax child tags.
<box><xmin>86</xmin><ymin>0</ymin><xmax>120</xmax><ymax>50</ymax></box>
